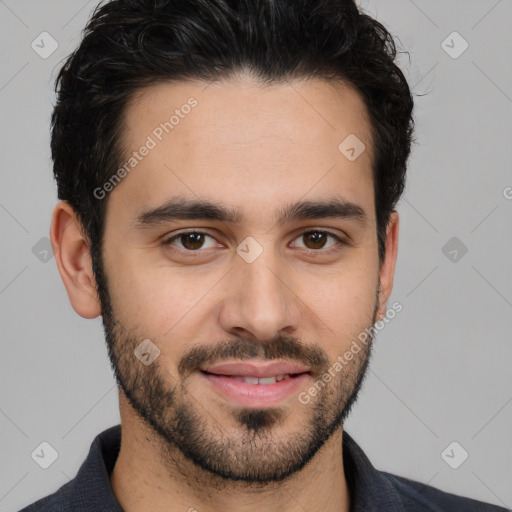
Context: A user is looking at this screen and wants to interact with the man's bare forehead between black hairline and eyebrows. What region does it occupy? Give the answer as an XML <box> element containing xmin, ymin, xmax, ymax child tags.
<box><xmin>112</xmin><ymin>78</ymin><xmax>373</xmax><ymax>220</ymax></box>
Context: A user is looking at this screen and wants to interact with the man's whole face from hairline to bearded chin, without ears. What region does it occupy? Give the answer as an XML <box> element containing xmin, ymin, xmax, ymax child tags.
<box><xmin>90</xmin><ymin>78</ymin><xmax>389</xmax><ymax>482</ymax></box>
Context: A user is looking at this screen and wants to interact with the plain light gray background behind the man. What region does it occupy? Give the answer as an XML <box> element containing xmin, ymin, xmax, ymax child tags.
<box><xmin>0</xmin><ymin>0</ymin><xmax>512</xmax><ymax>512</ymax></box>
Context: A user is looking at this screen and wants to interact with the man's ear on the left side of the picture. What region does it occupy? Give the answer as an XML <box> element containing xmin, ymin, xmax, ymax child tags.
<box><xmin>50</xmin><ymin>201</ymin><xmax>101</xmax><ymax>318</ymax></box>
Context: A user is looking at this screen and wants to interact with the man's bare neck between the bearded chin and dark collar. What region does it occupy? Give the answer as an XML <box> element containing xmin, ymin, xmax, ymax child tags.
<box><xmin>110</xmin><ymin>394</ymin><xmax>350</xmax><ymax>512</ymax></box>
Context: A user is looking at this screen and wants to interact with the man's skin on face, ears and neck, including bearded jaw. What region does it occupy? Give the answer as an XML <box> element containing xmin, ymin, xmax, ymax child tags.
<box><xmin>51</xmin><ymin>76</ymin><xmax>398</xmax><ymax>512</ymax></box>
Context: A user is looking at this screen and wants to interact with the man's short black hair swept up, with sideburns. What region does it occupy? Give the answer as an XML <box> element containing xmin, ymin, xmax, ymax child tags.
<box><xmin>51</xmin><ymin>0</ymin><xmax>414</xmax><ymax>269</ymax></box>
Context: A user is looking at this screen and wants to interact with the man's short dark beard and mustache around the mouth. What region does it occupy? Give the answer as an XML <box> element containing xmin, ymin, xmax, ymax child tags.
<box><xmin>95</xmin><ymin>252</ymin><xmax>380</xmax><ymax>486</ymax></box>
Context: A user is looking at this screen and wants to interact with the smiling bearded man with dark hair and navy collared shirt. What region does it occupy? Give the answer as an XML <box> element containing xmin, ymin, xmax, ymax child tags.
<box><xmin>18</xmin><ymin>0</ymin><xmax>504</xmax><ymax>512</ymax></box>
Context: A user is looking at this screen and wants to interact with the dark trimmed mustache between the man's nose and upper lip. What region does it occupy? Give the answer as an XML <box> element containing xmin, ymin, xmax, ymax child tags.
<box><xmin>178</xmin><ymin>335</ymin><xmax>329</xmax><ymax>377</ymax></box>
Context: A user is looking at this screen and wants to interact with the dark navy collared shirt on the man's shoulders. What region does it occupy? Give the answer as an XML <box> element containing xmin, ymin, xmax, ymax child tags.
<box><xmin>20</xmin><ymin>425</ymin><xmax>510</xmax><ymax>512</ymax></box>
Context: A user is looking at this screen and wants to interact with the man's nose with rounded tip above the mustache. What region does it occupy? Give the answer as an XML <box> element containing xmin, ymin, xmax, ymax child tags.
<box><xmin>219</xmin><ymin>246</ymin><xmax>301</xmax><ymax>341</ymax></box>
